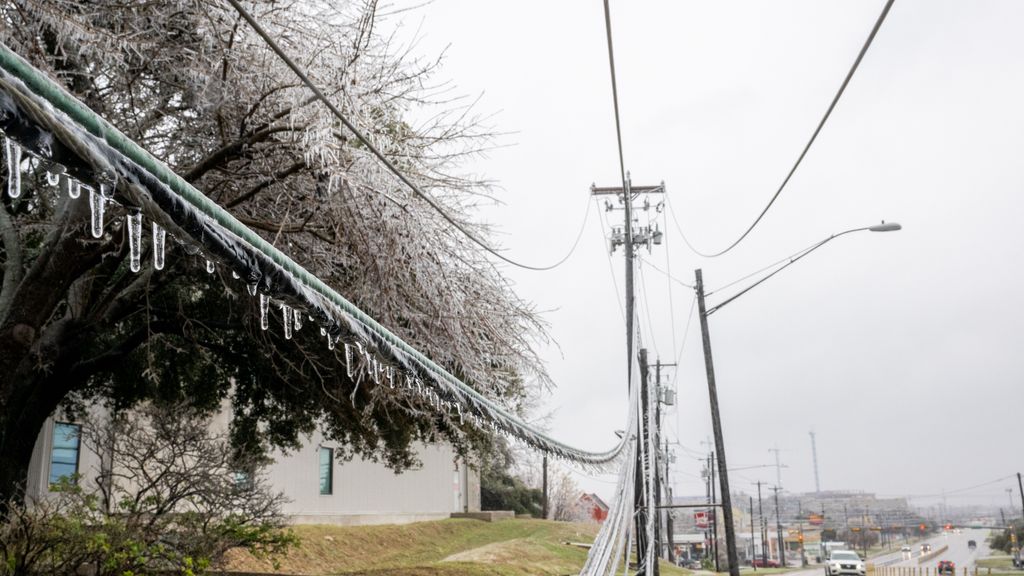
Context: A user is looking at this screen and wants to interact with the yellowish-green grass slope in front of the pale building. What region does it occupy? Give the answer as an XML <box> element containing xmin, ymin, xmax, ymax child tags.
<box><xmin>225</xmin><ymin>520</ymin><xmax>689</xmax><ymax>576</ymax></box>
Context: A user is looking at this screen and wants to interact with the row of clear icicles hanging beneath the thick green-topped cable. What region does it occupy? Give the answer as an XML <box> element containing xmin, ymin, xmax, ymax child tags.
<box><xmin>4</xmin><ymin>137</ymin><xmax>528</xmax><ymax>444</ymax></box>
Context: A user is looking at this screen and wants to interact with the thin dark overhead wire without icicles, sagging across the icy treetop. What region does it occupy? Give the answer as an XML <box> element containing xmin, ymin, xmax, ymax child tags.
<box><xmin>227</xmin><ymin>0</ymin><xmax>589</xmax><ymax>272</ymax></box>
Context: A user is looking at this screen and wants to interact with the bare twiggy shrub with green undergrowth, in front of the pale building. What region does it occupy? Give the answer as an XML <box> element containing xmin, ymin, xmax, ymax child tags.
<box><xmin>0</xmin><ymin>404</ymin><xmax>295</xmax><ymax>575</ymax></box>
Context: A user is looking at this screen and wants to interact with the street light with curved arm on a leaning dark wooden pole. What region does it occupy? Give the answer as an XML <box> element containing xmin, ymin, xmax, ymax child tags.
<box><xmin>695</xmin><ymin>220</ymin><xmax>902</xmax><ymax>576</ymax></box>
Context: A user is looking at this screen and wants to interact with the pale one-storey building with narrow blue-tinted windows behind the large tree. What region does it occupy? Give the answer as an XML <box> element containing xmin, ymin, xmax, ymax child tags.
<box><xmin>26</xmin><ymin>412</ymin><xmax>480</xmax><ymax>525</ymax></box>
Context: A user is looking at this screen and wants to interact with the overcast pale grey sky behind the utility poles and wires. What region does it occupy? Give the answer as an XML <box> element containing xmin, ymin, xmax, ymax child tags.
<box><xmin>385</xmin><ymin>0</ymin><xmax>1024</xmax><ymax>507</ymax></box>
